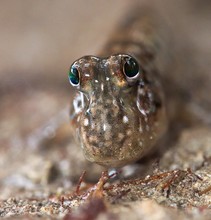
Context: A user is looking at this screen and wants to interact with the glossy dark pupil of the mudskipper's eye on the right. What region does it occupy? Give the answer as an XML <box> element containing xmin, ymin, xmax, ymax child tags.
<box><xmin>124</xmin><ymin>58</ymin><xmax>139</xmax><ymax>77</ymax></box>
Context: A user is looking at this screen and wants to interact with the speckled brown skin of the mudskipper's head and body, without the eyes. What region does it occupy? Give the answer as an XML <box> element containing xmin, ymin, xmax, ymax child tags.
<box><xmin>71</xmin><ymin>11</ymin><xmax>167</xmax><ymax>167</ymax></box>
